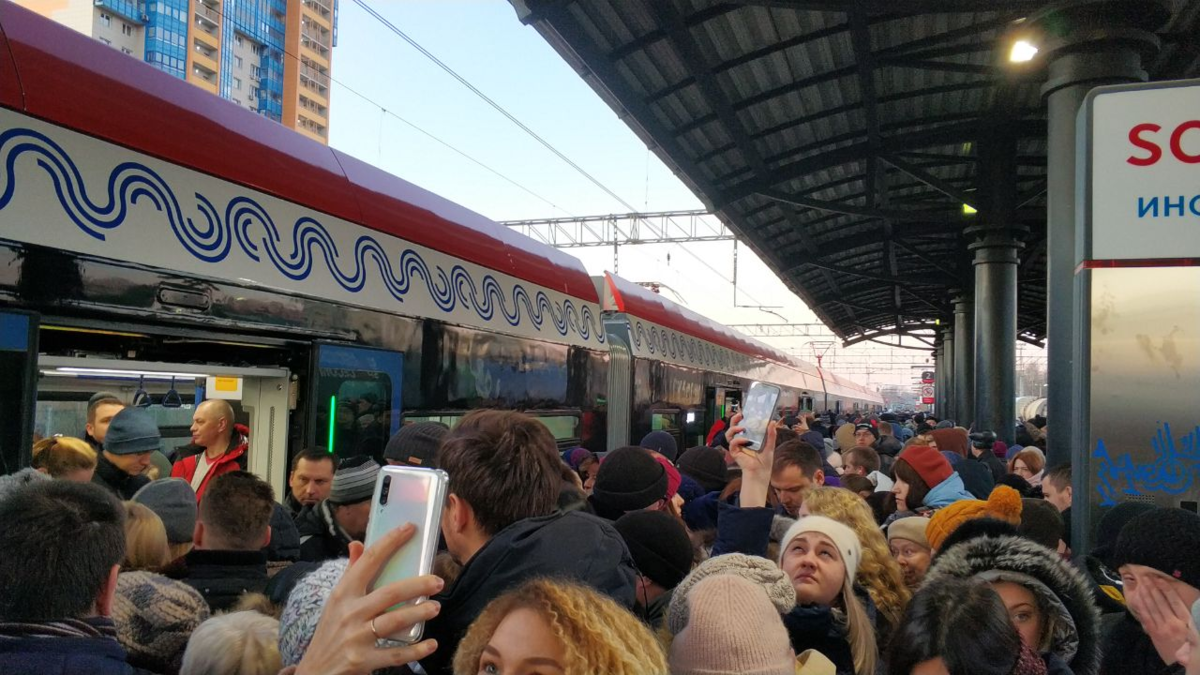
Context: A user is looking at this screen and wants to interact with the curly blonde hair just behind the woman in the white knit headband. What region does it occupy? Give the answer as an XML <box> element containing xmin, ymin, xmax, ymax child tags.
<box><xmin>804</xmin><ymin>486</ymin><xmax>912</xmax><ymax>627</ymax></box>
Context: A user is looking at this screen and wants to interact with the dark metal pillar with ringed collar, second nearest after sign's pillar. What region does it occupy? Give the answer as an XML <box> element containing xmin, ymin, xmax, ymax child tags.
<box><xmin>967</xmin><ymin>130</ymin><xmax>1022</xmax><ymax>443</ymax></box>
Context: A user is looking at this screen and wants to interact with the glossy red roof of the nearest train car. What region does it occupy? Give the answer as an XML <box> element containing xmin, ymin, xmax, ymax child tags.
<box><xmin>0</xmin><ymin>0</ymin><xmax>599</xmax><ymax>303</ymax></box>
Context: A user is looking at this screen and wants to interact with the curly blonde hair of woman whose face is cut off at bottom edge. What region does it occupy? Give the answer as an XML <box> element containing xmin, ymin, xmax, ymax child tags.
<box><xmin>454</xmin><ymin>579</ymin><xmax>668</xmax><ymax>675</ymax></box>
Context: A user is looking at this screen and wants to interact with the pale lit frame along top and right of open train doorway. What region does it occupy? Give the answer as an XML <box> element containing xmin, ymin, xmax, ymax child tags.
<box><xmin>35</xmin><ymin>354</ymin><xmax>292</xmax><ymax>500</ymax></box>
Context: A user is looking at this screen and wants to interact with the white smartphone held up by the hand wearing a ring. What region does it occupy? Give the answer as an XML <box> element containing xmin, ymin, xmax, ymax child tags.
<box><xmin>365</xmin><ymin>466</ymin><xmax>450</xmax><ymax>645</ymax></box>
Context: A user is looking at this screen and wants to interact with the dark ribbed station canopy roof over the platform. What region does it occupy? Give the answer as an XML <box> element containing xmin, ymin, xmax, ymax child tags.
<box><xmin>512</xmin><ymin>0</ymin><xmax>1200</xmax><ymax>344</ymax></box>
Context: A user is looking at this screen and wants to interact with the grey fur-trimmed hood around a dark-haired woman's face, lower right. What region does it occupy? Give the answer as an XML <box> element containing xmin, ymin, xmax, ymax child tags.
<box><xmin>923</xmin><ymin>534</ymin><xmax>1100</xmax><ymax>675</ymax></box>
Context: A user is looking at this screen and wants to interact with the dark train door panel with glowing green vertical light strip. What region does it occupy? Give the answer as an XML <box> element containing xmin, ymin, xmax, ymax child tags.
<box><xmin>312</xmin><ymin>344</ymin><xmax>404</xmax><ymax>460</ymax></box>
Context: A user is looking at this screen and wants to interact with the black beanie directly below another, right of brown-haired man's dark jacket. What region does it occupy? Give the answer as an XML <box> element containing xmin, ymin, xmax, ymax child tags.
<box><xmin>613</xmin><ymin>510</ymin><xmax>692</xmax><ymax>591</ymax></box>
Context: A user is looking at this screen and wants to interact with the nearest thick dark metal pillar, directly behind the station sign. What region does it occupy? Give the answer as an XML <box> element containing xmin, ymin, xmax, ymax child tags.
<box><xmin>1028</xmin><ymin>0</ymin><xmax>1170</xmax><ymax>465</ymax></box>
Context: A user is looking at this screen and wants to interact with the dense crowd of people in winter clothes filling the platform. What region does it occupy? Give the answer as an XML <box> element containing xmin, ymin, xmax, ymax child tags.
<box><xmin>0</xmin><ymin>394</ymin><xmax>1200</xmax><ymax>675</ymax></box>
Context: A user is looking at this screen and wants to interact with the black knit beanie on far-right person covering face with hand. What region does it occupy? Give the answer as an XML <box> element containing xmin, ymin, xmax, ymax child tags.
<box><xmin>1112</xmin><ymin>508</ymin><xmax>1200</xmax><ymax>589</ymax></box>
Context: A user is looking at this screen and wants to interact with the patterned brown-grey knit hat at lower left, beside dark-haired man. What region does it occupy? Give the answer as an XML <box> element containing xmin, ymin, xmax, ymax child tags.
<box><xmin>113</xmin><ymin>572</ymin><xmax>209</xmax><ymax>673</ymax></box>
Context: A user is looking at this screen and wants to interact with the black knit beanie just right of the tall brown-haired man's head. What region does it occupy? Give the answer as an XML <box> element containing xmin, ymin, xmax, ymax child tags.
<box><xmin>590</xmin><ymin>446</ymin><xmax>667</xmax><ymax>520</ymax></box>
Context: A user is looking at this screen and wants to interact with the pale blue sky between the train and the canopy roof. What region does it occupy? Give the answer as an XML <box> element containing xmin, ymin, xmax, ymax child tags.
<box><xmin>330</xmin><ymin>0</ymin><xmax>1044</xmax><ymax>384</ymax></box>
